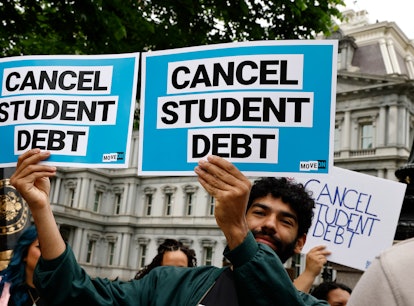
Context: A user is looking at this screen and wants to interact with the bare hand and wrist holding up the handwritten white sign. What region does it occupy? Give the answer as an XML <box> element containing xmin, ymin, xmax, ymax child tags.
<box><xmin>293</xmin><ymin>245</ymin><xmax>331</xmax><ymax>293</ymax></box>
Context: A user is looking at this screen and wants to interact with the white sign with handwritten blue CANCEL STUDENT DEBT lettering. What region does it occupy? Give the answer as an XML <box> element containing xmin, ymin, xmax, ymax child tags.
<box><xmin>295</xmin><ymin>167</ymin><xmax>407</xmax><ymax>270</ymax></box>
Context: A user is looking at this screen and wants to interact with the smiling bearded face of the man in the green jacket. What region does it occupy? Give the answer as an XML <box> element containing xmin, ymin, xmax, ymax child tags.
<box><xmin>246</xmin><ymin>195</ymin><xmax>306</xmax><ymax>262</ymax></box>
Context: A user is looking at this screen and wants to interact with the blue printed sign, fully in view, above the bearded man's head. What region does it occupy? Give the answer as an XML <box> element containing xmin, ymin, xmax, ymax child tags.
<box><xmin>138</xmin><ymin>40</ymin><xmax>337</xmax><ymax>176</ymax></box>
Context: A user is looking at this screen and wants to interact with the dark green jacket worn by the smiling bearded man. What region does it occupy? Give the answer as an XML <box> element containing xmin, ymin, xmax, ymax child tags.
<box><xmin>34</xmin><ymin>233</ymin><xmax>329</xmax><ymax>306</ymax></box>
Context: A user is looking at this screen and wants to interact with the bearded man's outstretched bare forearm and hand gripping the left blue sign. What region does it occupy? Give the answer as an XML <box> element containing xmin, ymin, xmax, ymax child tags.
<box><xmin>10</xmin><ymin>149</ymin><xmax>66</xmax><ymax>259</ymax></box>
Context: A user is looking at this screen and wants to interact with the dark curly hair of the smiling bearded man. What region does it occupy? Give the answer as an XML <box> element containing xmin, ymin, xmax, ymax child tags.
<box><xmin>247</xmin><ymin>177</ymin><xmax>315</xmax><ymax>237</ymax></box>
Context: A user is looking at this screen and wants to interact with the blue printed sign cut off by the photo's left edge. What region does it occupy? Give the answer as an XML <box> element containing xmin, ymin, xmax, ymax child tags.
<box><xmin>0</xmin><ymin>53</ymin><xmax>139</xmax><ymax>168</ymax></box>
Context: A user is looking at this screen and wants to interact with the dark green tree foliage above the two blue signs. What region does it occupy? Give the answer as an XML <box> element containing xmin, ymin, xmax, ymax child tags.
<box><xmin>0</xmin><ymin>0</ymin><xmax>344</xmax><ymax>57</ymax></box>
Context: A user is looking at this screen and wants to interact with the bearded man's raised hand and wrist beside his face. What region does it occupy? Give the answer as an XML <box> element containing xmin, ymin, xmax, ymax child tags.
<box><xmin>194</xmin><ymin>155</ymin><xmax>252</xmax><ymax>250</ymax></box>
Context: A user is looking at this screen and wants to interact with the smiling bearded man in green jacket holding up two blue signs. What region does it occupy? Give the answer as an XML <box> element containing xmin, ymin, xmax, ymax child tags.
<box><xmin>10</xmin><ymin>149</ymin><xmax>328</xmax><ymax>306</ymax></box>
